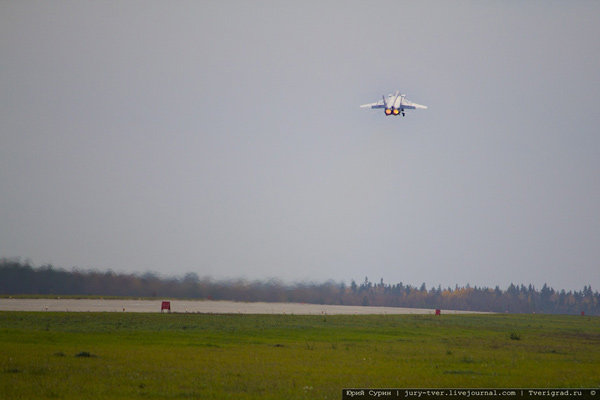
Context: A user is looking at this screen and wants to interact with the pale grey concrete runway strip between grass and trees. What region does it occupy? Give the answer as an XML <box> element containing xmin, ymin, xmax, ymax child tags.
<box><xmin>0</xmin><ymin>299</ymin><xmax>482</xmax><ymax>315</ymax></box>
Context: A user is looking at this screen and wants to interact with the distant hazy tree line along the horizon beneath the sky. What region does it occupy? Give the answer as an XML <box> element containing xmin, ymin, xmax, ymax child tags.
<box><xmin>0</xmin><ymin>258</ymin><xmax>600</xmax><ymax>315</ymax></box>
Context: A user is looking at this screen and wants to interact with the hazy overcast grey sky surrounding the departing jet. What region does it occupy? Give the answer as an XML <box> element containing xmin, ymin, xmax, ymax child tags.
<box><xmin>0</xmin><ymin>0</ymin><xmax>600</xmax><ymax>290</ymax></box>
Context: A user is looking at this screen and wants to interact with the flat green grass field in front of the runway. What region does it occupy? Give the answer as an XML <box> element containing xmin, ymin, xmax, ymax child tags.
<box><xmin>0</xmin><ymin>312</ymin><xmax>600</xmax><ymax>399</ymax></box>
